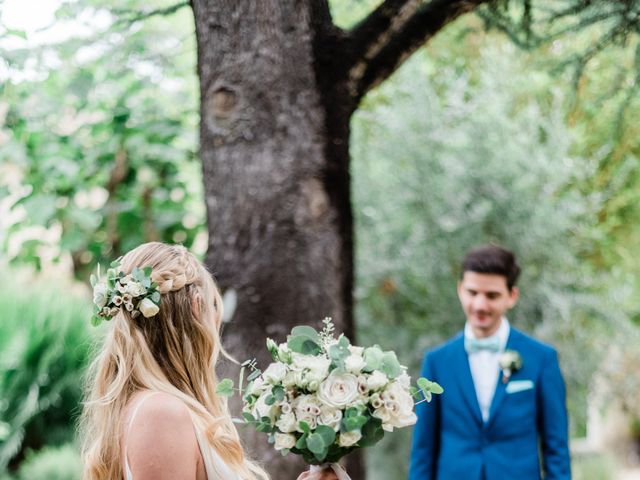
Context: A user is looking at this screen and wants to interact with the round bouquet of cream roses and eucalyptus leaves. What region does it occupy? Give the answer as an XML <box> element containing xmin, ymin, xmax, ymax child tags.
<box><xmin>218</xmin><ymin>318</ymin><xmax>442</xmax><ymax>465</ymax></box>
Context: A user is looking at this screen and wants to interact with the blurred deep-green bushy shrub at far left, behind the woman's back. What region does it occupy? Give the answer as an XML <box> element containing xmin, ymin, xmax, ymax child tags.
<box><xmin>0</xmin><ymin>269</ymin><xmax>90</xmax><ymax>472</ymax></box>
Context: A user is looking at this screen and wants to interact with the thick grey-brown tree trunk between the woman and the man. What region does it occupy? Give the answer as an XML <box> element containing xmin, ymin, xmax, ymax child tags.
<box><xmin>193</xmin><ymin>0</ymin><xmax>364</xmax><ymax>480</ymax></box>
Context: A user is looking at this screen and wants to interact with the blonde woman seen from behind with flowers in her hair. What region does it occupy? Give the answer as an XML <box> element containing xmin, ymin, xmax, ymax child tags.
<box><xmin>80</xmin><ymin>242</ymin><xmax>337</xmax><ymax>480</ymax></box>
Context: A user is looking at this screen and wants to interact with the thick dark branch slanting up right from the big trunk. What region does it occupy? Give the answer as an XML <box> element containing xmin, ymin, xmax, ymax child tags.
<box><xmin>347</xmin><ymin>0</ymin><xmax>487</xmax><ymax>100</ymax></box>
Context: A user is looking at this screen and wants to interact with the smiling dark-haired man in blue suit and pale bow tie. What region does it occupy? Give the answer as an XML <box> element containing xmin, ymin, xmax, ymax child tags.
<box><xmin>409</xmin><ymin>245</ymin><xmax>571</xmax><ymax>480</ymax></box>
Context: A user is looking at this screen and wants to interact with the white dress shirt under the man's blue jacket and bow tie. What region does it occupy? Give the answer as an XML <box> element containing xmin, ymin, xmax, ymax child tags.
<box><xmin>464</xmin><ymin>317</ymin><xmax>510</xmax><ymax>422</ymax></box>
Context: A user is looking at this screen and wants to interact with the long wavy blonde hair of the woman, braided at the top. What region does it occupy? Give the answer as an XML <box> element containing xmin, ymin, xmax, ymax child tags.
<box><xmin>80</xmin><ymin>242</ymin><xmax>268</xmax><ymax>480</ymax></box>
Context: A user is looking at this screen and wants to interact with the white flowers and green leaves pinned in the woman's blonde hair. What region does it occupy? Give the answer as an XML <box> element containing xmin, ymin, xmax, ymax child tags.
<box><xmin>91</xmin><ymin>258</ymin><xmax>160</xmax><ymax>326</ymax></box>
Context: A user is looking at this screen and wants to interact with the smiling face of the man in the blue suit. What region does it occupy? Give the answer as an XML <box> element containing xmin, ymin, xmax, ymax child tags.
<box><xmin>458</xmin><ymin>271</ymin><xmax>518</xmax><ymax>337</ymax></box>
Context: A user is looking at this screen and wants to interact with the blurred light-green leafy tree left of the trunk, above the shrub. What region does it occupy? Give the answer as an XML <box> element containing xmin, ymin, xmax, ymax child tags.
<box><xmin>0</xmin><ymin>2</ymin><xmax>206</xmax><ymax>278</ymax></box>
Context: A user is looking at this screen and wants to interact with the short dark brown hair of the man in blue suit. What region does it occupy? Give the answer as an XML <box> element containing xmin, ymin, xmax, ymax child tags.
<box><xmin>460</xmin><ymin>245</ymin><xmax>520</xmax><ymax>290</ymax></box>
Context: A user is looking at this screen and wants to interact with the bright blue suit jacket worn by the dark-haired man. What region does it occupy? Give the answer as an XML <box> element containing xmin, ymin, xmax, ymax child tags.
<box><xmin>409</xmin><ymin>327</ymin><xmax>571</xmax><ymax>480</ymax></box>
